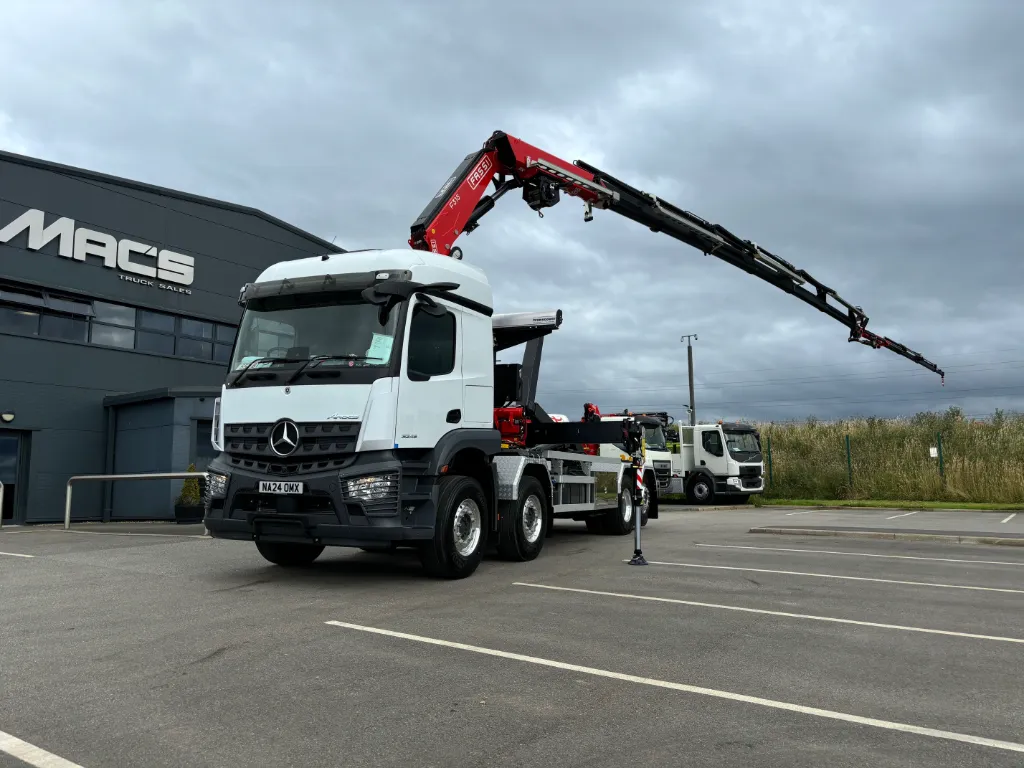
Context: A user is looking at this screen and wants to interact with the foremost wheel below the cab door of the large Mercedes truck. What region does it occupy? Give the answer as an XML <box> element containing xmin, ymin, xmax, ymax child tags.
<box><xmin>420</xmin><ymin>475</ymin><xmax>487</xmax><ymax>579</ymax></box>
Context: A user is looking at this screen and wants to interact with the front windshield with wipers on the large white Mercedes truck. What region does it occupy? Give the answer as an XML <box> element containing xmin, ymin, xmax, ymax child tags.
<box><xmin>231</xmin><ymin>294</ymin><xmax>398</xmax><ymax>371</ymax></box>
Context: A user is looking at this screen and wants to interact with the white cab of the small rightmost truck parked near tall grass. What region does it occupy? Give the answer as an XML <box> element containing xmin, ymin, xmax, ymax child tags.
<box><xmin>669</xmin><ymin>421</ymin><xmax>764</xmax><ymax>504</ymax></box>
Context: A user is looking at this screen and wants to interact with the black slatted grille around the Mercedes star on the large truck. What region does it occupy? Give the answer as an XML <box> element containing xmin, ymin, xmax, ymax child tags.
<box><xmin>224</xmin><ymin>422</ymin><xmax>361</xmax><ymax>475</ymax></box>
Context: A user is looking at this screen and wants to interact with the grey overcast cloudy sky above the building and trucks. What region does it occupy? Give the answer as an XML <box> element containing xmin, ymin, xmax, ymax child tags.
<box><xmin>0</xmin><ymin>0</ymin><xmax>1024</xmax><ymax>420</ymax></box>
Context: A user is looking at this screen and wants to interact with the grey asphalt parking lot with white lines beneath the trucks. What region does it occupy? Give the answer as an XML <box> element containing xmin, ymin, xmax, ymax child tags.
<box><xmin>0</xmin><ymin>508</ymin><xmax>1024</xmax><ymax>768</ymax></box>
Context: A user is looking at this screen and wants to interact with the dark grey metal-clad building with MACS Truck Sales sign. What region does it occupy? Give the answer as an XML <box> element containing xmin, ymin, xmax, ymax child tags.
<box><xmin>0</xmin><ymin>152</ymin><xmax>343</xmax><ymax>524</ymax></box>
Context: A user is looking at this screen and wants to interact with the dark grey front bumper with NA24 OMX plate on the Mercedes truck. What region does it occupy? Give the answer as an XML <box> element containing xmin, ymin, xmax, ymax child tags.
<box><xmin>205</xmin><ymin>451</ymin><xmax>437</xmax><ymax>547</ymax></box>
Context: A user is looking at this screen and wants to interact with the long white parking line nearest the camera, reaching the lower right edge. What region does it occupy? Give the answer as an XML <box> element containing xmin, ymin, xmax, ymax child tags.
<box><xmin>325</xmin><ymin>622</ymin><xmax>1024</xmax><ymax>753</ymax></box>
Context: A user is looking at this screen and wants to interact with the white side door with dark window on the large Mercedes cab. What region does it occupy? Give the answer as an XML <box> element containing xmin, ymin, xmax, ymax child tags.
<box><xmin>394</xmin><ymin>296</ymin><xmax>463</xmax><ymax>447</ymax></box>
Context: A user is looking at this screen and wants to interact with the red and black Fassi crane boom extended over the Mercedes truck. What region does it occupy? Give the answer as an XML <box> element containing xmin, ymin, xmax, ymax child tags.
<box><xmin>409</xmin><ymin>131</ymin><xmax>945</xmax><ymax>384</ymax></box>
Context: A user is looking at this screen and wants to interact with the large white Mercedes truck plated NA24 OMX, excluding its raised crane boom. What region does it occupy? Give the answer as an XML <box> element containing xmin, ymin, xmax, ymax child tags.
<box><xmin>205</xmin><ymin>250</ymin><xmax>655</xmax><ymax>578</ymax></box>
